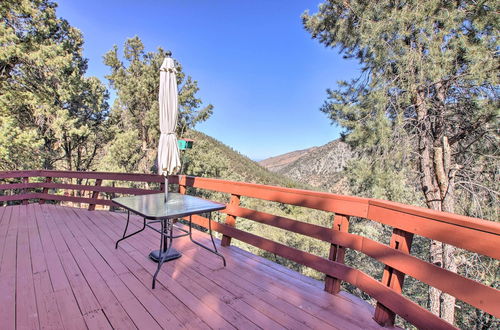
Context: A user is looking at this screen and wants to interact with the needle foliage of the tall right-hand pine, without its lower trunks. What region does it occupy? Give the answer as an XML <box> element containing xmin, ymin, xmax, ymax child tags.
<box><xmin>303</xmin><ymin>1</ymin><xmax>498</xmax><ymax>209</ymax></box>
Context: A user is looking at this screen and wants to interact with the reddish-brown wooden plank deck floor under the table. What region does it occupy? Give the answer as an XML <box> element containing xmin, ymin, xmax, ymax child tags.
<box><xmin>0</xmin><ymin>204</ymin><xmax>388</xmax><ymax>329</ymax></box>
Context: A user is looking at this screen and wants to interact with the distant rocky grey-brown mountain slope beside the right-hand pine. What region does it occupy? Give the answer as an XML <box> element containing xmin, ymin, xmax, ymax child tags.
<box><xmin>259</xmin><ymin>140</ymin><xmax>354</xmax><ymax>193</ymax></box>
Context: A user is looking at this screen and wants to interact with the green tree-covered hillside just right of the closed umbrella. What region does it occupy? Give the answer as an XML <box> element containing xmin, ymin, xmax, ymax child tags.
<box><xmin>181</xmin><ymin>130</ymin><xmax>306</xmax><ymax>188</ymax></box>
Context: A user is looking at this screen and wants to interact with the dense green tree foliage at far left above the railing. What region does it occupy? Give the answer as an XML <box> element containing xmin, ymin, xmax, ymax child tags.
<box><xmin>0</xmin><ymin>0</ymin><xmax>108</xmax><ymax>170</ymax></box>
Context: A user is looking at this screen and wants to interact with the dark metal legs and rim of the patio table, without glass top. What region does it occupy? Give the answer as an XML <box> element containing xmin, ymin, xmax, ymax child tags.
<box><xmin>113</xmin><ymin>193</ymin><xmax>226</xmax><ymax>289</ymax></box>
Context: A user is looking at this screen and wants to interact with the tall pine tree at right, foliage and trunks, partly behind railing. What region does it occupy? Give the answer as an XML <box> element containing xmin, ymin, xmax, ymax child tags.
<box><xmin>303</xmin><ymin>0</ymin><xmax>499</xmax><ymax>323</ymax></box>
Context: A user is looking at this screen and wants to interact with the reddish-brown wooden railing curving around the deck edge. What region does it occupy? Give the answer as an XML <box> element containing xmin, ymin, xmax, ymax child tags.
<box><xmin>0</xmin><ymin>170</ymin><xmax>500</xmax><ymax>329</ymax></box>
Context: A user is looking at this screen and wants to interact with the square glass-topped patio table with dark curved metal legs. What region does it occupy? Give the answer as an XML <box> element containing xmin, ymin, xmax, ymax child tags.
<box><xmin>112</xmin><ymin>192</ymin><xmax>226</xmax><ymax>289</ymax></box>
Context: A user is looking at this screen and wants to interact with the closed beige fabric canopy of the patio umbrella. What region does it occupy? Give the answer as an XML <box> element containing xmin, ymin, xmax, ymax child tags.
<box><xmin>158</xmin><ymin>57</ymin><xmax>181</xmax><ymax>175</ymax></box>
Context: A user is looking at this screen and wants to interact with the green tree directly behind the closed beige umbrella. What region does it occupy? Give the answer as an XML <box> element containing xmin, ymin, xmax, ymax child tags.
<box><xmin>100</xmin><ymin>37</ymin><xmax>213</xmax><ymax>173</ymax></box>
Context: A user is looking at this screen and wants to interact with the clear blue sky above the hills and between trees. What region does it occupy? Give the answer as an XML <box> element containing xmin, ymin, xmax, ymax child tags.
<box><xmin>57</xmin><ymin>0</ymin><xmax>358</xmax><ymax>159</ymax></box>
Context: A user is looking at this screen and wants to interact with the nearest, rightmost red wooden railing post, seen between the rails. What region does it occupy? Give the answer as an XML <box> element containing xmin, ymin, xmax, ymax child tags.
<box><xmin>374</xmin><ymin>228</ymin><xmax>413</xmax><ymax>327</ymax></box>
